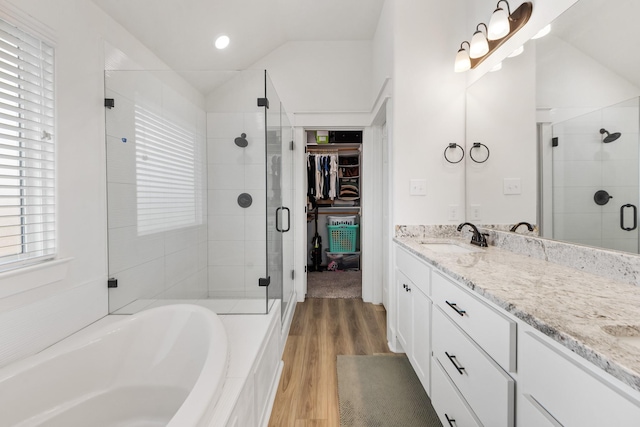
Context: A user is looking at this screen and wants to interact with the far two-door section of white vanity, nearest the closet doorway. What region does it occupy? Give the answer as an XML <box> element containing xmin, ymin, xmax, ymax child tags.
<box><xmin>396</xmin><ymin>249</ymin><xmax>431</xmax><ymax>394</ymax></box>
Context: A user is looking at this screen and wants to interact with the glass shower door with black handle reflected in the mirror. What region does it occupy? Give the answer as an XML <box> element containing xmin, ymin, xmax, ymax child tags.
<box><xmin>552</xmin><ymin>98</ymin><xmax>640</xmax><ymax>253</ymax></box>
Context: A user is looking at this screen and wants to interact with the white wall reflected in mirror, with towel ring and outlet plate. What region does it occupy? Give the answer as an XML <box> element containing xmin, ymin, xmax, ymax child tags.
<box><xmin>465</xmin><ymin>45</ymin><xmax>537</xmax><ymax>225</ymax></box>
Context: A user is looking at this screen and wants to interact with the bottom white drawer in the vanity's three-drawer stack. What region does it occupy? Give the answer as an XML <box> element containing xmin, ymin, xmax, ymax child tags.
<box><xmin>431</xmin><ymin>358</ymin><xmax>482</xmax><ymax>427</ymax></box>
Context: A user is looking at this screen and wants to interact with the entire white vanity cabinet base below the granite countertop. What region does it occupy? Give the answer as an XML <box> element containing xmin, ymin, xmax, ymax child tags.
<box><xmin>395</xmin><ymin>245</ymin><xmax>640</xmax><ymax>427</ymax></box>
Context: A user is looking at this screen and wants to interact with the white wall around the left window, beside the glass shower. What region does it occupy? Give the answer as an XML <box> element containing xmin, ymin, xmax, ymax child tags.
<box><xmin>0</xmin><ymin>0</ymin><xmax>200</xmax><ymax>364</ymax></box>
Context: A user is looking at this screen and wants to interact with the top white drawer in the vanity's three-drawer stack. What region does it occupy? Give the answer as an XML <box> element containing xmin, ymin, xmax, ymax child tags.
<box><xmin>431</xmin><ymin>271</ymin><xmax>517</xmax><ymax>372</ymax></box>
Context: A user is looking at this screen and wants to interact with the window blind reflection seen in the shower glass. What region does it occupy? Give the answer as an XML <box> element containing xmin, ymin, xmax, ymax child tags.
<box><xmin>135</xmin><ymin>104</ymin><xmax>202</xmax><ymax>235</ymax></box>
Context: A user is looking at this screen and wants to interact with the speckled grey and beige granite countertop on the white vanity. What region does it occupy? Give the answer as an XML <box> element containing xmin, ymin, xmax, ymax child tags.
<box><xmin>394</xmin><ymin>237</ymin><xmax>640</xmax><ymax>391</ymax></box>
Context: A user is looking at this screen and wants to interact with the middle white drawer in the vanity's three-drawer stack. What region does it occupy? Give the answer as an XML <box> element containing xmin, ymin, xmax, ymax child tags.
<box><xmin>432</xmin><ymin>307</ymin><xmax>514</xmax><ymax>427</ymax></box>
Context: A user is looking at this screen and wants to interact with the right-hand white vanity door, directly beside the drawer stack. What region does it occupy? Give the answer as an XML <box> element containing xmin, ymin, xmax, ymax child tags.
<box><xmin>410</xmin><ymin>288</ymin><xmax>431</xmax><ymax>395</ymax></box>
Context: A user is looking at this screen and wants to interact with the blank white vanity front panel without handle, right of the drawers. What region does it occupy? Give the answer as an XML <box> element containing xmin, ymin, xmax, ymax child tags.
<box><xmin>518</xmin><ymin>331</ymin><xmax>640</xmax><ymax>427</ymax></box>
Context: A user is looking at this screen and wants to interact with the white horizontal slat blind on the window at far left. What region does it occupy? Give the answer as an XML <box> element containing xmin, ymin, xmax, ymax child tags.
<box><xmin>0</xmin><ymin>19</ymin><xmax>56</xmax><ymax>270</ymax></box>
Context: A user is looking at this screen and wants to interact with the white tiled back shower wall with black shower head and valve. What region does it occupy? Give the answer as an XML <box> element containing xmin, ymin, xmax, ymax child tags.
<box><xmin>207</xmin><ymin>108</ymin><xmax>266</xmax><ymax>298</ymax></box>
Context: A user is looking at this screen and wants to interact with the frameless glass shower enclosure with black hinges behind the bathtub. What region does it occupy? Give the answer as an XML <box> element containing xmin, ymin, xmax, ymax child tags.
<box><xmin>105</xmin><ymin>70</ymin><xmax>293</xmax><ymax>314</ymax></box>
